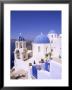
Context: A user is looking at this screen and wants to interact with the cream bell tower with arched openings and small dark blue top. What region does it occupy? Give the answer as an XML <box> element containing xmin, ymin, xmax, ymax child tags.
<box><xmin>14</xmin><ymin>36</ymin><xmax>28</xmax><ymax>60</ymax></box>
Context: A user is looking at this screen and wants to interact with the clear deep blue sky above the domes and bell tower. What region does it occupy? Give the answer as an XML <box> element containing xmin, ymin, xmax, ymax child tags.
<box><xmin>11</xmin><ymin>11</ymin><xmax>61</xmax><ymax>39</ymax></box>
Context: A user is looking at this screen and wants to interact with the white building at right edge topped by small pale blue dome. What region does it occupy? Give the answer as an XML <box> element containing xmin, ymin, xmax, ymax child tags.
<box><xmin>48</xmin><ymin>31</ymin><xmax>62</xmax><ymax>58</ymax></box>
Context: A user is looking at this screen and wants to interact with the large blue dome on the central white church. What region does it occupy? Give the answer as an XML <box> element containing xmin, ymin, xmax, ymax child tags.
<box><xmin>34</xmin><ymin>34</ymin><xmax>50</xmax><ymax>43</ymax></box>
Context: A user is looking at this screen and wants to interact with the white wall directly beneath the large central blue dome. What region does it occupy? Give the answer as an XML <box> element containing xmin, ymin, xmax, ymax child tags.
<box><xmin>32</xmin><ymin>43</ymin><xmax>50</xmax><ymax>59</ymax></box>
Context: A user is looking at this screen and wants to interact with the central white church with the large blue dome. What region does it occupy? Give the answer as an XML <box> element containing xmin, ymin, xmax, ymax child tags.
<box><xmin>32</xmin><ymin>33</ymin><xmax>51</xmax><ymax>60</ymax></box>
